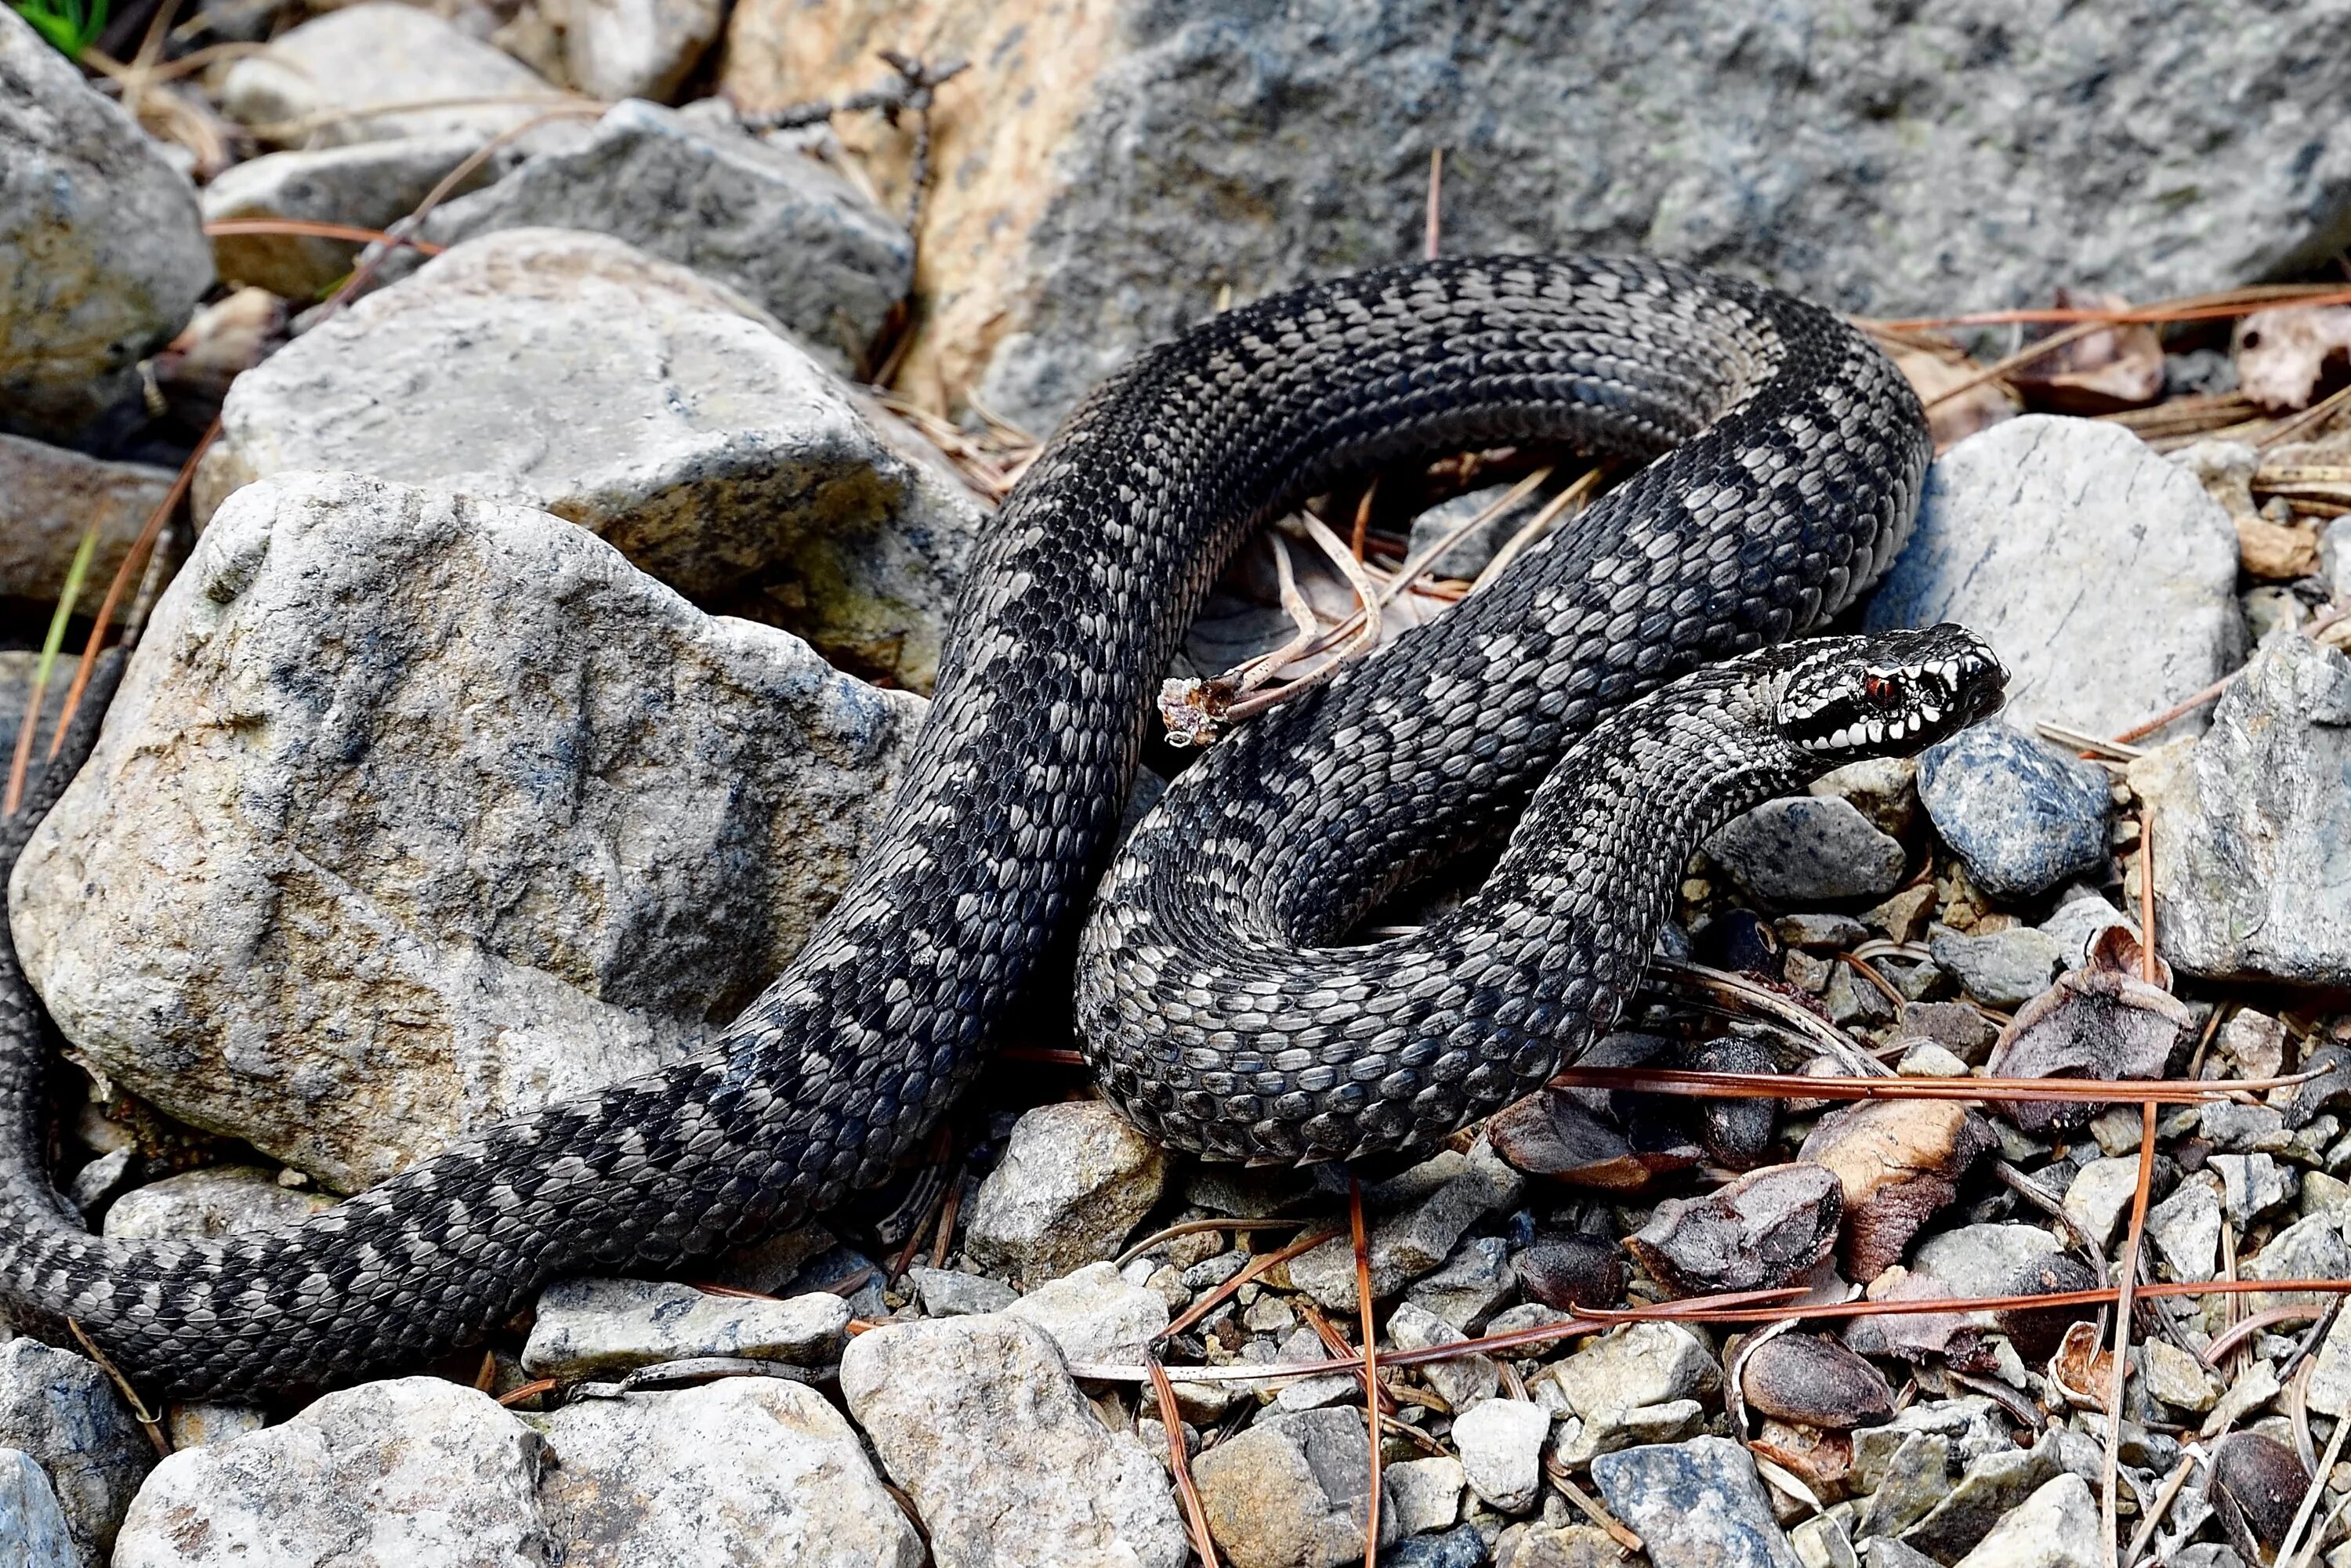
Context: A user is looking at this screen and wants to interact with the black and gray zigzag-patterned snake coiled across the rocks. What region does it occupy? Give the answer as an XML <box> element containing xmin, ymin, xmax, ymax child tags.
<box><xmin>0</xmin><ymin>256</ymin><xmax>1998</xmax><ymax>1399</ymax></box>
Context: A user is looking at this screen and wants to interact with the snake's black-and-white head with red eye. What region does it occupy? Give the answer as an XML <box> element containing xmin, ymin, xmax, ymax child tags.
<box><xmin>1777</xmin><ymin>623</ymin><xmax>2008</xmax><ymax>764</ymax></box>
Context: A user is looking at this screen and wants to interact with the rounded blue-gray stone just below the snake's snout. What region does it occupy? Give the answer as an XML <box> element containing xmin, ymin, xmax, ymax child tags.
<box><xmin>1918</xmin><ymin>724</ymin><xmax>2114</xmax><ymax>898</ymax></box>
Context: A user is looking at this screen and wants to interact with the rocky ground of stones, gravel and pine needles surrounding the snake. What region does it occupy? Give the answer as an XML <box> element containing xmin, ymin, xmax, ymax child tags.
<box><xmin>0</xmin><ymin>0</ymin><xmax>2351</xmax><ymax>1568</ymax></box>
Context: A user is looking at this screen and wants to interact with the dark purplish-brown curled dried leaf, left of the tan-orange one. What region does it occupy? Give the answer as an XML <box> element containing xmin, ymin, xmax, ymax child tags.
<box><xmin>1625</xmin><ymin>1164</ymin><xmax>1846</xmax><ymax>1295</ymax></box>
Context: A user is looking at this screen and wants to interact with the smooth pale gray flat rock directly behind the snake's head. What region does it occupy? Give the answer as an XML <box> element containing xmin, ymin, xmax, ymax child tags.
<box><xmin>1867</xmin><ymin>416</ymin><xmax>2245</xmax><ymax>738</ymax></box>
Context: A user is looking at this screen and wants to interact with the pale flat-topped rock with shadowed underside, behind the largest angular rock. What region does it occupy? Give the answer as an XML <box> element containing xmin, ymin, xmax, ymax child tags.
<box><xmin>193</xmin><ymin>223</ymin><xmax>980</xmax><ymax>691</ymax></box>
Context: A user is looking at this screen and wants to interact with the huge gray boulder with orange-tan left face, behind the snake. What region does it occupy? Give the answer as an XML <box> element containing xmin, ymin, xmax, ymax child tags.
<box><xmin>719</xmin><ymin>0</ymin><xmax>2351</xmax><ymax>428</ymax></box>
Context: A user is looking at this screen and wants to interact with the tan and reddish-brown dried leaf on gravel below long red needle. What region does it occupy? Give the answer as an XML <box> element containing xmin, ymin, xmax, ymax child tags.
<box><xmin>1796</xmin><ymin>1100</ymin><xmax>1994</xmax><ymax>1279</ymax></box>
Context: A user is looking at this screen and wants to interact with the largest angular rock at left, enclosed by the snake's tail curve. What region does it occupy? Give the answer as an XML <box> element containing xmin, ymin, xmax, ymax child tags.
<box><xmin>12</xmin><ymin>475</ymin><xmax>924</xmax><ymax>1192</ymax></box>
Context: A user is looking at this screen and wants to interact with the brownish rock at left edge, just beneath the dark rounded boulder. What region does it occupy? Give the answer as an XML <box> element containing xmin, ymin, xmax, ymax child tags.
<box><xmin>0</xmin><ymin>442</ymin><xmax>172</xmax><ymax>611</ymax></box>
